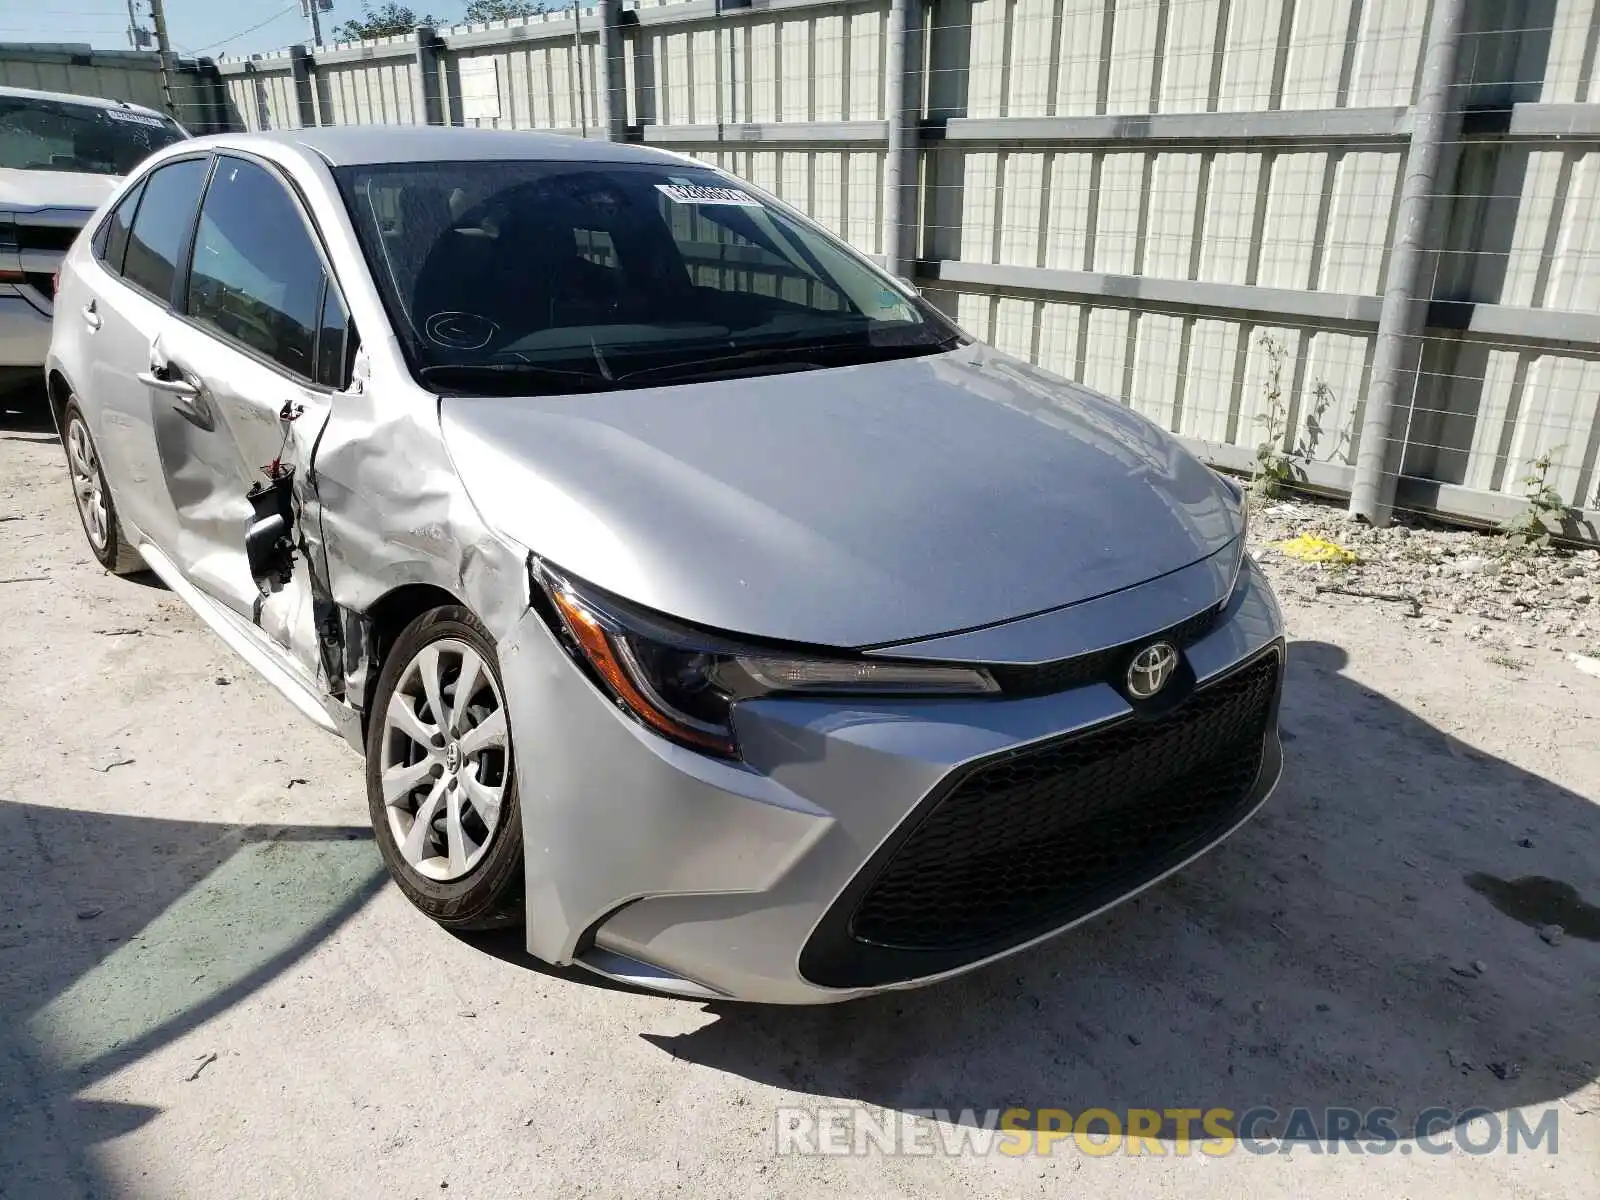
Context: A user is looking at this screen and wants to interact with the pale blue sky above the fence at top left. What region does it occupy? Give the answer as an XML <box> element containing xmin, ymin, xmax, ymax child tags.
<box><xmin>0</xmin><ymin>0</ymin><xmax>531</xmax><ymax>56</ymax></box>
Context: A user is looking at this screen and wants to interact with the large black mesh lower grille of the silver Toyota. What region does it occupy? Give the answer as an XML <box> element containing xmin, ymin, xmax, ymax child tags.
<box><xmin>800</xmin><ymin>648</ymin><xmax>1282</xmax><ymax>986</ymax></box>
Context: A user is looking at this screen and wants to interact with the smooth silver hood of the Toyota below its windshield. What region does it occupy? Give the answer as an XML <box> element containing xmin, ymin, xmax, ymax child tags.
<box><xmin>440</xmin><ymin>346</ymin><xmax>1240</xmax><ymax>646</ymax></box>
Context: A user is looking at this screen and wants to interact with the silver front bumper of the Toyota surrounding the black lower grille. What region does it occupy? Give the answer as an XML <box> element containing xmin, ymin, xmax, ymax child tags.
<box><xmin>501</xmin><ymin>560</ymin><xmax>1282</xmax><ymax>1003</ymax></box>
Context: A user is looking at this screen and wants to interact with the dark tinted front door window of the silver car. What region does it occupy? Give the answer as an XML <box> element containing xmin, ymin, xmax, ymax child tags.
<box><xmin>187</xmin><ymin>157</ymin><xmax>324</xmax><ymax>379</ymax></box>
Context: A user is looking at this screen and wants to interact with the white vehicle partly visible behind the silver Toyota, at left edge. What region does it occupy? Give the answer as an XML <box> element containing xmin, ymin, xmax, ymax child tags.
<box><xmin>0</xmin><ymin>88</ymin><xmax>189</xmax><ymax>406</ymax></box>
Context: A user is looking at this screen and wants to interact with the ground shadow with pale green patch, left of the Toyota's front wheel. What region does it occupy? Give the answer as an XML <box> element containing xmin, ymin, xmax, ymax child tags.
<box><xmin>0</xmin><ymin>800</ymin><xmax>386</xmax><ymax>1200</ymax></box>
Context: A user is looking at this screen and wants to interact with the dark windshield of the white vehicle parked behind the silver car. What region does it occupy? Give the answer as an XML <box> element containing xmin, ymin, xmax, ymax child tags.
<box><xmin>0</xmin><ymin>96</ymin><xmax>186</xmax><ymax>174</ymax></box>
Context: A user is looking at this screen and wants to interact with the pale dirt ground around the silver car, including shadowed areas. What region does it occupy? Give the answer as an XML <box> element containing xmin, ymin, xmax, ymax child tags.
<box><xmin>0</xmin><ymin>396</ymin><xmax>1600</xmax><ymax>1200</ymax></box>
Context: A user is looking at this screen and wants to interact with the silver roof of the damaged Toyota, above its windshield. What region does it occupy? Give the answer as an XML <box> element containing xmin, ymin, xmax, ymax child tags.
<box><xmin>202</xmin><ymin>125</ymin><xmax>683</xmax><ymax>166</ymax></box>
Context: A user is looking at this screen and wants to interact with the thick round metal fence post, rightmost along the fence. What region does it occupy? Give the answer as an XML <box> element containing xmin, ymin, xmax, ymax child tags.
<box><xmin>1350</xmin><ymin>0</ymin><xmax>1467</xmax><ymax>526</ymax></box>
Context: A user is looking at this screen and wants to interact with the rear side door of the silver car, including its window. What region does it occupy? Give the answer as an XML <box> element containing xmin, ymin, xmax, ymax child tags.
<box><xmin>81</xmin><ymin>155</ymin><xmax>211</xmax><ymax>546</ymax></box>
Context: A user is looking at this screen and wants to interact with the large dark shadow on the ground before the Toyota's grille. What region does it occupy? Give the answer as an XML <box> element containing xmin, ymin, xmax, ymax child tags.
<box><xmin>643</xmin><ymin>642</ymin><xmax>1600</xmax><ymax>1128</ymax></box>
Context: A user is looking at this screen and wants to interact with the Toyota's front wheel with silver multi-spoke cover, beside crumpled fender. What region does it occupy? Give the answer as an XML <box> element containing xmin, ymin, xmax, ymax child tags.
<box><xmin>366</xmin><ymin>605</ymin><xmax>523</xmax><ymax>930</ymax></box>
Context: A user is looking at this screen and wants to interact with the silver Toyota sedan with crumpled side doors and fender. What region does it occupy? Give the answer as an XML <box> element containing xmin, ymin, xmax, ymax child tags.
<box><xmin>48</xmin><ymin>128</ymin><xmax>1285</xmax><ymax>1003</ymax></box>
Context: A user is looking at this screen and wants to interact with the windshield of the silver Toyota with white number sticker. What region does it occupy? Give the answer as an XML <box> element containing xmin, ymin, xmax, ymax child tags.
<box><xmin>336</xmin><ymin>162</ymin><xmax>960</xmax><ymax>395</ymax></box>
